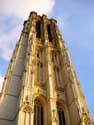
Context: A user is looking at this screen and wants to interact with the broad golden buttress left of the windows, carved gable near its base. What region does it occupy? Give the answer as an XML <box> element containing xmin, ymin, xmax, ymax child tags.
<box><xmin>18</xmin><ymin>14</ymin><xmax>33</xmax><ymax>125</ymax></box>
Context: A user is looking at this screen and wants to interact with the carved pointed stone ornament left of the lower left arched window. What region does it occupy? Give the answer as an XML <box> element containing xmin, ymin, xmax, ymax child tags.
<box><xmin>22</xmin><ymin>96</ymin><xmax>32</xmax><ymax>113</ymax></box>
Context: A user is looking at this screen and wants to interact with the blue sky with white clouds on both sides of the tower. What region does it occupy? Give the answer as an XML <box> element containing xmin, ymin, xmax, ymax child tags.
<box><xmin>0</xmin><ymin>0</ymin><xmax>94</xmax><ymax>117</ymax></box>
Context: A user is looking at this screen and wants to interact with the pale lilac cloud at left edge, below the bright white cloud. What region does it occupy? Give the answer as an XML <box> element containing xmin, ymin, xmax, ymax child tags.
<box><xmin>0</xmin><ymin>22</ymin><xmax>22</xmax><ymax>61</ymax></box>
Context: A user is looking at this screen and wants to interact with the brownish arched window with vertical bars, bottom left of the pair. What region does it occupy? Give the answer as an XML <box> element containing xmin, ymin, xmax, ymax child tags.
<box><xmin>34</xmin><ymin>100</ymin><xmax>44</xmax><ymax>125</ymax></box>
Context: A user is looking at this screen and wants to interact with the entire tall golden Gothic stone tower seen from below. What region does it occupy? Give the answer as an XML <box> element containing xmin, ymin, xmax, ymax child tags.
<box><xmin>0</xmin><ymin>12</ymin><xmax>90</xmax><ymax>125</ymax></box>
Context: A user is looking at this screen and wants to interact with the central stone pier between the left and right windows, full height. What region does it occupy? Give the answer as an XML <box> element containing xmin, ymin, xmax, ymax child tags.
<box><xmin>43</xmin><ymin>15</ymin><xmax>58</xmax><ymax>125</ymax></box>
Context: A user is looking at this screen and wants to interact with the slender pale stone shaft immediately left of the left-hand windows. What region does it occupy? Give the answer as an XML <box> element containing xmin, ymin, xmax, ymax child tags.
<box><xmin>30</xmin><ymin>12</ymin><xmax>37</xmax><ymax>125</ymax></box>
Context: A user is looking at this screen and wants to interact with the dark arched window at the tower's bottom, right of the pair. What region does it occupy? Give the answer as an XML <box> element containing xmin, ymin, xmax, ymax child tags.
<box><xmin>57</xmin><ymin>105</ymin><xmax>65</xmax><ymax>125</ymax></box>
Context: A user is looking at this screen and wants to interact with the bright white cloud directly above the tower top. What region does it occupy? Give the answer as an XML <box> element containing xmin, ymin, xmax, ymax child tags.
<box><xmin>0</xmin><ymin>0</ymin><xmax>55</xmax><ymax>17</ymax></box>
